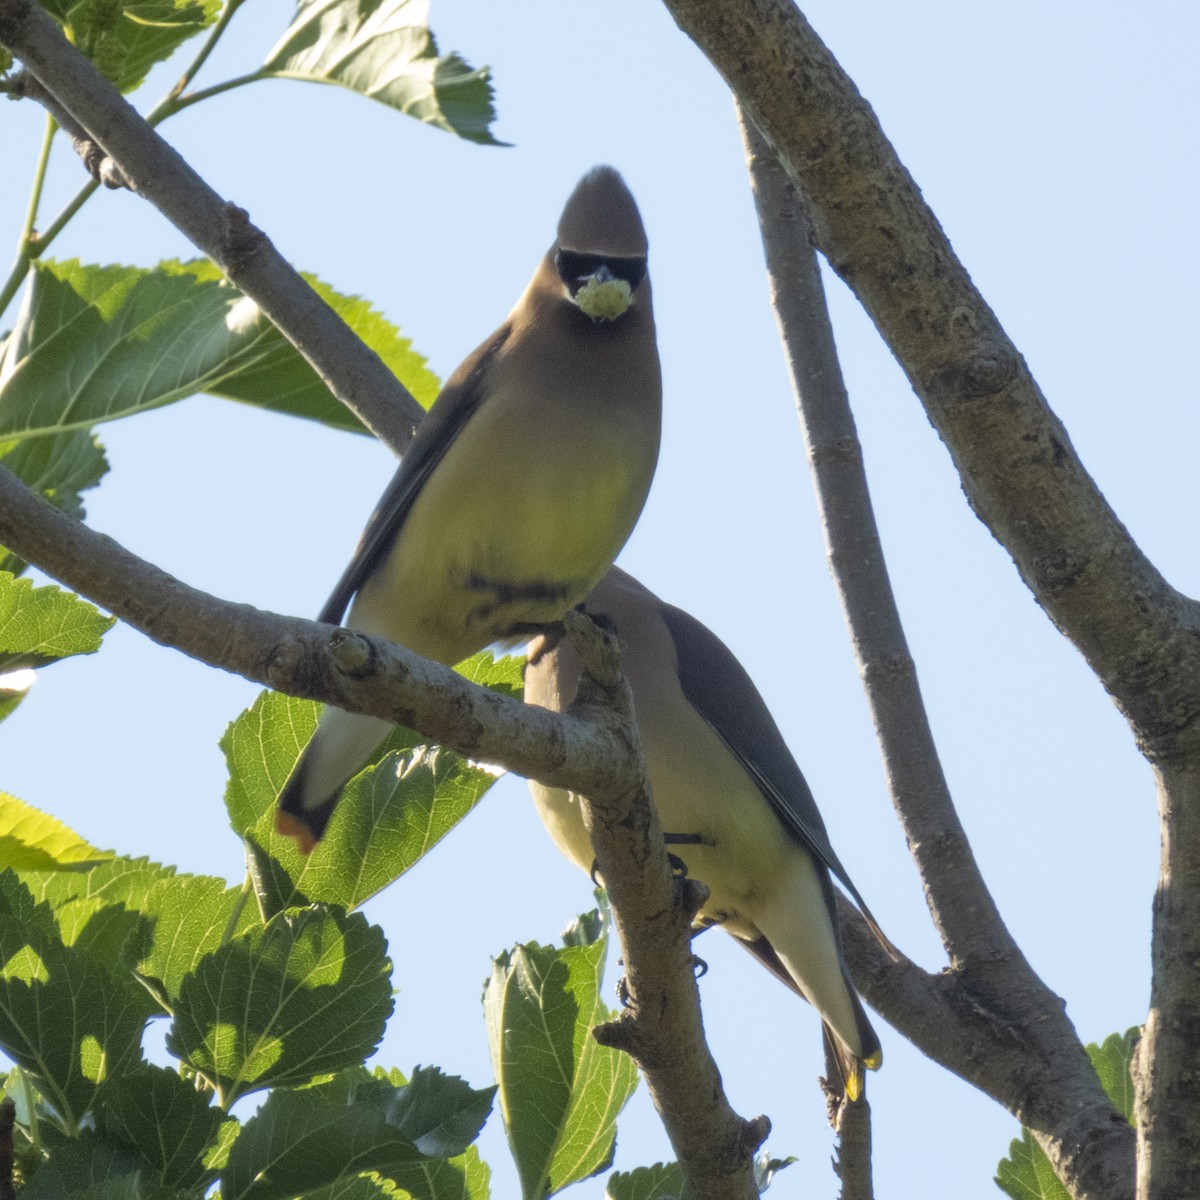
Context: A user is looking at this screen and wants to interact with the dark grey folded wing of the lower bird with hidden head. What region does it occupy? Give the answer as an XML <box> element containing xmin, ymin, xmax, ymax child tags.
<box><xmin>662</xmin><ymin>604</ymin><xmax>892</xmax><ymax>947</ymax></box>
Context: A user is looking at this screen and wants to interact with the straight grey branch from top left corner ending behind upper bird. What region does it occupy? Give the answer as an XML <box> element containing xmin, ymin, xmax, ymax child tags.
<box><xmin>0</xmin><ymin>0</ymin><xmax>422</xmax><ymax>454</ymax></box>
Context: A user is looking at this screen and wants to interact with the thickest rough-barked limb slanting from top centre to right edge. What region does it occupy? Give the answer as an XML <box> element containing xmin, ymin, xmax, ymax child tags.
<box><xmin>665</xmin><ymin>0</ymin><xmax>1200</xmax><ymax>760</ymax></box>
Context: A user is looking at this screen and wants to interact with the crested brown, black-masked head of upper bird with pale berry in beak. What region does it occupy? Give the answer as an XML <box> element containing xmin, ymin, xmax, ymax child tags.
<box><xmin>554</xmin><ymin>167</ymin><xmax>647</xmax><ymax>320</ymax></box>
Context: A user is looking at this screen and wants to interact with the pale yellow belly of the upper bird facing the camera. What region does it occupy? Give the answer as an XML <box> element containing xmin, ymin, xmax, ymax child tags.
<box><xmin>349</xmin><ymin>400</ymin><xmax>654</xmax><ymax>664</ymax></box>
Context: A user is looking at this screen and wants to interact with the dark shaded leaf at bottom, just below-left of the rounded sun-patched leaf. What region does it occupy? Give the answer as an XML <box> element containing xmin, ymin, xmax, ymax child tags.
<box><xmin>101</xmin><ymin>1063</ymin><xmax>236</xmax><ymax>1192</ymax></box>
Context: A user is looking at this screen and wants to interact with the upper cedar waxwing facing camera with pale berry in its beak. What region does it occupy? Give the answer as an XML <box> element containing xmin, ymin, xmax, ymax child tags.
<box><xmin>276</xmin><ymin>167</ymin><xmax>662</xmax><ymax>852</ymax></box>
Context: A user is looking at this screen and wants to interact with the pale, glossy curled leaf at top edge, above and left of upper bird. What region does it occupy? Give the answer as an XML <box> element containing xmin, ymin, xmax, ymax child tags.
<box><xmin>263</xmin><ymin>0</ymin><xmax>503</xmax><ymax>145</ymax></box>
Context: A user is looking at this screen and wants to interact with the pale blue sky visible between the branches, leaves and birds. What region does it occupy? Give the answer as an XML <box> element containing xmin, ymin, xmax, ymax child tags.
<box><xmin>0</xmin><ymin>0</ymin><xmax>1200</xmax><ymax>1200</ymax></box>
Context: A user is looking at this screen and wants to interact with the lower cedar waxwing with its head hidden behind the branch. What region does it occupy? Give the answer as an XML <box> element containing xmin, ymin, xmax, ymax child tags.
<box><xmin>524</xmin><ymin>568</ymin><xmax>892</xmax><ymax>1099</ymax></box>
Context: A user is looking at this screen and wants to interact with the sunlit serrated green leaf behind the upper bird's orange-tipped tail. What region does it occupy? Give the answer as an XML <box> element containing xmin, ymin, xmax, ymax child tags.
<box><xmin>221</xmin><ymin>692</ymin><xmax>496</xmax><ymax>908</ymax></box>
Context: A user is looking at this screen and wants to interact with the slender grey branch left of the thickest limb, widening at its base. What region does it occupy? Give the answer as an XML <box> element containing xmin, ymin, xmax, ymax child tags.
<box><xmin>742</xmin><ymin>113</ymin><xmax>1133</xmax><ymax>1196</ymax></box>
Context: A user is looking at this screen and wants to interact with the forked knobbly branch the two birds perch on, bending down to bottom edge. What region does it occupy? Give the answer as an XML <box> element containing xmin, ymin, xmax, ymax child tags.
<box><xmin>0</xmin><ymin>467</ymin><xmax>769</xmax><ymax>1200</ymax></box>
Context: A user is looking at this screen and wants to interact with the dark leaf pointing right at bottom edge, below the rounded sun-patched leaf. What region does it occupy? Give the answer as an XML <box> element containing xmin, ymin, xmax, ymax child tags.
<box><xmin>221</xmin><ymin>1091</ymin><xmax>424</xmax><ymax>1200</ymax></box>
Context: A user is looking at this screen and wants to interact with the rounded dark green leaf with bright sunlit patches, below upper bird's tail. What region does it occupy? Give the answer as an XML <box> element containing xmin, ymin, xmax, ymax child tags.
<box><xmin>167</xmin><ymin>907</ymin><xmax>392</xmax><ymax>1108</ymax></box>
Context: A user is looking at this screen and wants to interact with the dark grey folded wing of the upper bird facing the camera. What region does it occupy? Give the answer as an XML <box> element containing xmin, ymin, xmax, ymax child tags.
<box><xmin>317</xmin><ymin>322</ymin><xmax>511</xmax><ymax>625</ymax></box>
